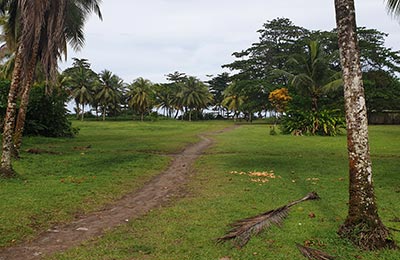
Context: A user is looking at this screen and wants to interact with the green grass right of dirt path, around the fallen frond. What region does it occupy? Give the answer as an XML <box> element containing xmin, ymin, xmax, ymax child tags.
<box><xmin>46</xmin><ymin>125</ymin><xmax>400</xmax><ymax>260</ymax></box>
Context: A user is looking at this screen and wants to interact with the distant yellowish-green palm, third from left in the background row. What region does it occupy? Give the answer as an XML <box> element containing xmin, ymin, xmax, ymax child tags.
<box><xmin>127</xmin><ymin>78</ymin><xmax>154</xmax><ymax>121</ymax></box>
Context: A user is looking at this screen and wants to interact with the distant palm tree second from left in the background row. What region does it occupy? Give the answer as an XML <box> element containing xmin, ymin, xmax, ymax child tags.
<box><xmin>94</xmin><ymin>70</ymin><xmax>122</xmax><ymax>121</ymax></box>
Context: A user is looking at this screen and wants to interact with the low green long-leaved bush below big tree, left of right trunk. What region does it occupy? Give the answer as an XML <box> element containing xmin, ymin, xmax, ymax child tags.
<box><xmin>281</xmin><ymin>110</ymin><xmax>345</xmax><ymax>136</ymax></box>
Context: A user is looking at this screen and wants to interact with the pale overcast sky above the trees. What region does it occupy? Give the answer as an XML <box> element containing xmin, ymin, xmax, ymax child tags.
<box><xmin>60</xmin><ymin>0</ymin><xmax>400</xmax><ymax>83</ymax></box>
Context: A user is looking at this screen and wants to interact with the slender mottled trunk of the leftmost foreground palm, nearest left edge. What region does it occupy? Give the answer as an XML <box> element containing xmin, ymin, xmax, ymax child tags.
<box><xmin>0</xmin><ymin>44</ymin><xmax>24</xmax><ymax>177</ymax></box>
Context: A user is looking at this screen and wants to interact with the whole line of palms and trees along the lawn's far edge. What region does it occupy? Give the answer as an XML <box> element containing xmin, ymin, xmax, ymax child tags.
<box><xmin>0</xmin><ymin>18</ymin><xmax>400</xmax><ymax>136</ymax></box>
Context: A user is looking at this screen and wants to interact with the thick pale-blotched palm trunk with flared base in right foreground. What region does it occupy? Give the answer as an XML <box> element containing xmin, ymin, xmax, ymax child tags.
<box><xmin>335</xmin><ymin>0</ymin><xmax>395</xmax><ymax>250</ymax></box>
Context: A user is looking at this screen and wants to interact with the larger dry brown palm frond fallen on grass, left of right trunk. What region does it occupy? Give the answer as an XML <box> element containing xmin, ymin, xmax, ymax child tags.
<box><xmin>217</xmin><ymin>192</ymin><xmax>319</xmax><ymax>248</ymax></box>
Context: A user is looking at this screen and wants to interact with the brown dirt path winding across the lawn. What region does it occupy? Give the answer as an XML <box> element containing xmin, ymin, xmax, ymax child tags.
<box><xmin>0</xmin><ymin>127</ymin><xmax>238</xmax><ymax>260</ymax></box>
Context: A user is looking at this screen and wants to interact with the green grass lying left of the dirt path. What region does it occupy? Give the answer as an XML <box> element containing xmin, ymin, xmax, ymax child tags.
<box><xmin>0</xmin><ymin>121</ymin><xmax>229</xmax><ymax>247</ymax></box>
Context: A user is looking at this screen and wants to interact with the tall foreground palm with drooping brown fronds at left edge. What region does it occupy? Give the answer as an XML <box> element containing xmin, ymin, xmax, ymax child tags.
<box><xmin>0</xmin><ymin>0</ymin><xmax>101</xmax><ymax>177</ymax></box>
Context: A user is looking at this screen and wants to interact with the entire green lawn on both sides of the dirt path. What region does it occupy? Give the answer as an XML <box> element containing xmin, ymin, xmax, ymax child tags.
<box><xmin>0</xmin><ymin>122</ymin><xmax>400</xmax><ymax>260</ymax></box>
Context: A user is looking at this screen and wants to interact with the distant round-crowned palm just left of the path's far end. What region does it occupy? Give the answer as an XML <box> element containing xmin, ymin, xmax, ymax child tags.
<box><xmin>181</xmin><ymin>76</ymin><xmax>212</xmax><ymax>121</ymax></box>
